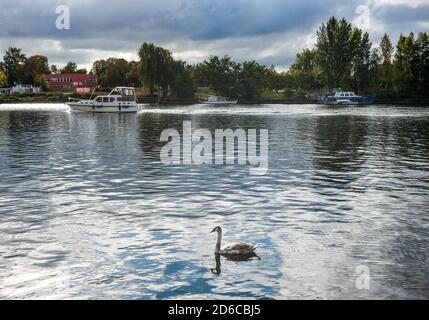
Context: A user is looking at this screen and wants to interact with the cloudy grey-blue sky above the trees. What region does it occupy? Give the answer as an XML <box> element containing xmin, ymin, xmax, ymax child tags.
<box><xmin>0</xmin><ymin>0</ymin><xmax>429</xmax><ymax>69</ymax></box>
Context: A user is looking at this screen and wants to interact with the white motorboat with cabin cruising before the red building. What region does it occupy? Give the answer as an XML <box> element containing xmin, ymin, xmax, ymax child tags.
<box><xmin>67</xmin><ymin>87</ymin><xmax>138</xmax><ymax>113</ymax></box>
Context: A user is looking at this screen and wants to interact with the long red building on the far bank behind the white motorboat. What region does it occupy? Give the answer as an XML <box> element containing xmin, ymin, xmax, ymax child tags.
<box><xmin>45</xmin><ymin>73</ymin><xmax>98</xmax><ymax>93</ymax></box>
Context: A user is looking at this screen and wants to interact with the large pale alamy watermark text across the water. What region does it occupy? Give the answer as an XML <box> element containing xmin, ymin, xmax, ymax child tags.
<box><xmin>160</xmin><ymin>121</ymin><xmax>268</xmax><ymax>175</ymax></box>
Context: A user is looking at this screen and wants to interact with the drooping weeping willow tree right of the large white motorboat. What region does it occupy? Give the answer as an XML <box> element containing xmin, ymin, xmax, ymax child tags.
<box><xmin>138</xmin><ymin>43</ymin><xmax>176</xmax><ymax>96</ymax></box>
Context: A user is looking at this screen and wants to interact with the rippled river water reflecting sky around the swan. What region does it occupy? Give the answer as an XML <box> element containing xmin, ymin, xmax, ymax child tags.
<box><xmin>0</xmin><ymin>104</ymin><xmax>429</xmax><ymax>299</ymax></box>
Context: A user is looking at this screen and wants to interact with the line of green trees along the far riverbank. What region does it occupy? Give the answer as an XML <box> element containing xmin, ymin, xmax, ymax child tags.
<box><xmin>0</xmin><ymin>17</ymin><xmax>429</xmax><ymax>100</ymax></box>
